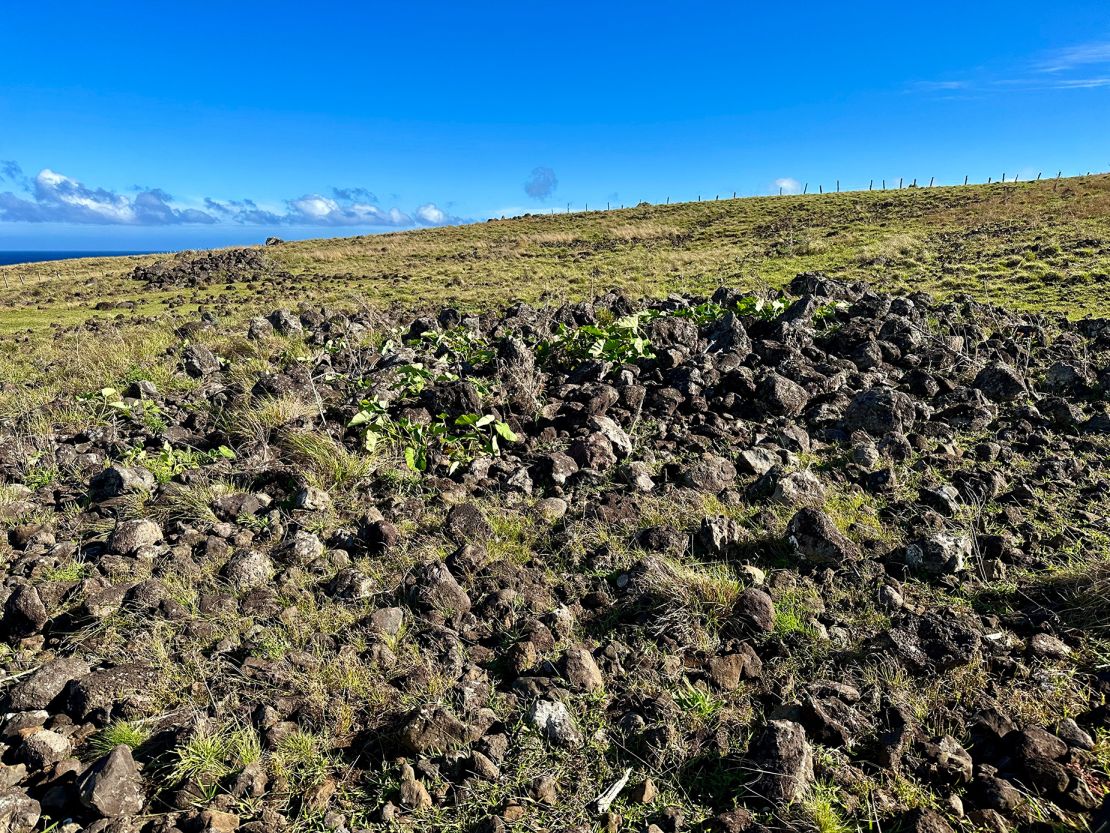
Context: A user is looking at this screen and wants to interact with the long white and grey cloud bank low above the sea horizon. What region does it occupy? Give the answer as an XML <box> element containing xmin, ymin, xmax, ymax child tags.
<box><xmin>0</xmin><ymin>160</ymin><xmax>470</xmax><ymax>229</ymax></box>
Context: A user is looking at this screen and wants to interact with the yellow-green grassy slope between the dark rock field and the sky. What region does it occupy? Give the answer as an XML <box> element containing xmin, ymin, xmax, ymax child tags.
<box><xmin>0</xmin><ymin>175</ymin><xmax>1110</xmax><ymax>342</ymax></box>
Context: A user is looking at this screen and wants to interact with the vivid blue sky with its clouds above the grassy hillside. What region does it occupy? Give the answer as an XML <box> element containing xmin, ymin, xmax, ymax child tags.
<box><xmin>0</xmin><ymin>0</ymin><xmax>1110</xmax><ymax>250</ymax></box>
